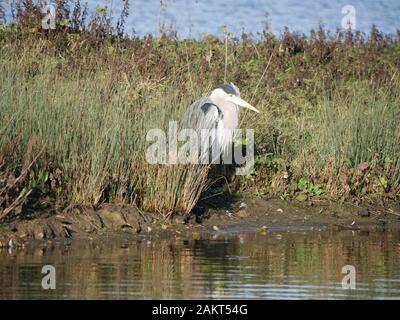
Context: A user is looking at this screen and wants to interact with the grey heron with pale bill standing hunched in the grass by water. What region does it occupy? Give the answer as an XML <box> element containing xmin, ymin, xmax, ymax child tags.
<box><xmin>183</xmin><ymin>83</ymin><xmax>259</xmax><ymax>163</ymax></box>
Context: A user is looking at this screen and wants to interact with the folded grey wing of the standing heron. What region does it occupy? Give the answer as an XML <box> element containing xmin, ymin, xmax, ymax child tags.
<box><xmin>182</xmin><ymin>97</ymin><xmax>223</xmax><ymax>163</ymax></box>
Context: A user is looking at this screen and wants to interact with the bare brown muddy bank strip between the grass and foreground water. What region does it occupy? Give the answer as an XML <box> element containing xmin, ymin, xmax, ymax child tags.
<box><xmin>0</xmin><ymin>199</ymin><xmax>400</xmax><ymax>247</ymax></box>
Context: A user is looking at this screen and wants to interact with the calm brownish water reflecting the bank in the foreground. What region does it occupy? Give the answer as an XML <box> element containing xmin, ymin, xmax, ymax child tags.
<box><xmin>0</xmin><ymin>231</ymin><xmax>400</xmax><ymax>299</ymax></box>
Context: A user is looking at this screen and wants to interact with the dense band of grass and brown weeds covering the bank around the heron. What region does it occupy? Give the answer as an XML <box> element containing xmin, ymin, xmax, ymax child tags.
<box><xmin>0</xmin><ymin>0</ymin><xmax>400</xmax><ymax>220</ymax></box>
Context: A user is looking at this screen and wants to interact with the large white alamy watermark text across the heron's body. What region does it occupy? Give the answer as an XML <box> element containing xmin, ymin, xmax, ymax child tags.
<box><xmin>146</xmin><ymin>121</ymin><xmax>254</xmax><ymax>175</ymax></box>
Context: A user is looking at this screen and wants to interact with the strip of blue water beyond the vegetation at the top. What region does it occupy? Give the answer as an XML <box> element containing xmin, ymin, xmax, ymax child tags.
<box><xmin>0</xmin><ymin>0</ymin><xmax>400</xmax><ymax>38</ymax></box>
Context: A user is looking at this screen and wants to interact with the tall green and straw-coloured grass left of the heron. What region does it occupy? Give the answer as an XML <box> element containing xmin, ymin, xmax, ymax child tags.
<box><xmin>0</xmin><ymin>41</ymin><xmax>208</xmax><ymax>216</ymax></box>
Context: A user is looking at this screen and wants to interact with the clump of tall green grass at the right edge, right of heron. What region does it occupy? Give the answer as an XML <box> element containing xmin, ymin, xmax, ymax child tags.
<box><xmin>294</xmin><ymin>82</ymin><xmax>400</xmax><ymax>196</ymax></box>
